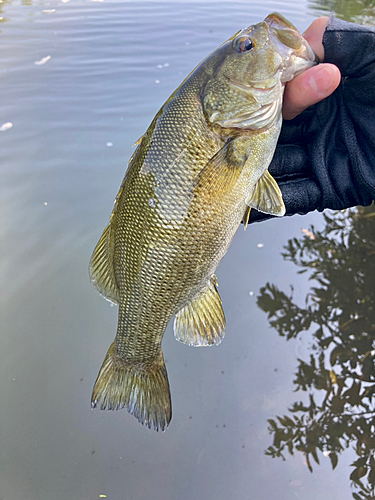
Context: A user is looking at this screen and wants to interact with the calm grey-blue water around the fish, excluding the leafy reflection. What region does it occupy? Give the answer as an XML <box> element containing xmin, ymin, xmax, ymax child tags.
<box><xmin>0</xmin><ymin>0</ymin><xmax>370</xmax><ymax>500</ymax></box>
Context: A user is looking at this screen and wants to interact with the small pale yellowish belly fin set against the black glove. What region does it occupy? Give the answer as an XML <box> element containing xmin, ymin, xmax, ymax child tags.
<box><xmin>246</xmin><ymin>170</ymin><xmax>285</xmax><ymax>217</ymax></box>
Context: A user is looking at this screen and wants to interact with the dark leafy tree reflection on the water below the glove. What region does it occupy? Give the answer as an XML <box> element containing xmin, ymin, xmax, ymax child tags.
<box><xmin>258</xmin><ymin>205</ymin><xmax>375</xmax><ymax>500</ymax></box>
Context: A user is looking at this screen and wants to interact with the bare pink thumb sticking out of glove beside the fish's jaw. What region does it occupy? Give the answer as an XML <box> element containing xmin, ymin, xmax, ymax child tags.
<box><xmin>283</xmin><ymin>64</ymin><xmax>341</xmax><ymax>120</ymax></box>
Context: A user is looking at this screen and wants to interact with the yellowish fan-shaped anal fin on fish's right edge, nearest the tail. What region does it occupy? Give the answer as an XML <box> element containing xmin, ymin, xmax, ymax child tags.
<box><xmin>174</xmin><ymin>275</ymin><xmax>225</xmax><ymax>347</ymax></box>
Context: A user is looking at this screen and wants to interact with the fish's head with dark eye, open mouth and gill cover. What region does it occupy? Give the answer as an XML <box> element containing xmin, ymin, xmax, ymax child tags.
<box><xmin>203</xmin><ymin>13</ymin><xmax>318</xmax><ymax>130</ymax></box>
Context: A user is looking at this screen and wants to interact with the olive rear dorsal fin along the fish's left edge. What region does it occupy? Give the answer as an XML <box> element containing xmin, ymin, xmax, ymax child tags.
<box><xmin>90</xmin><ymin>222</ymin><xmax>120</xmax><ymax>304</ymax></box>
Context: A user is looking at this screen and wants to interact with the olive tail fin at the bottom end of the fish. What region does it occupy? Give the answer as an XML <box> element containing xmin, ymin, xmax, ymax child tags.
<box><xmin>91</xmin><ymin>343</ymin><xmax>172</xmax><ymax>431</ymax></box>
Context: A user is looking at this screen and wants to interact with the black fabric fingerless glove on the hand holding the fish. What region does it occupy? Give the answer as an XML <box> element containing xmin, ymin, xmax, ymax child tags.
<box><xmin>250</xmin><ymin>15</ymin><xmax>375</xmax><ymax>222</ymax></box>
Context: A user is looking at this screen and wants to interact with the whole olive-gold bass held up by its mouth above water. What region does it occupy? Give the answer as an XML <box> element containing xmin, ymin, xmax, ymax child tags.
<box><xmin>90</xmin><ymin>13</ymin><xmax>317</xmax><ymax>431</ymax></box>
